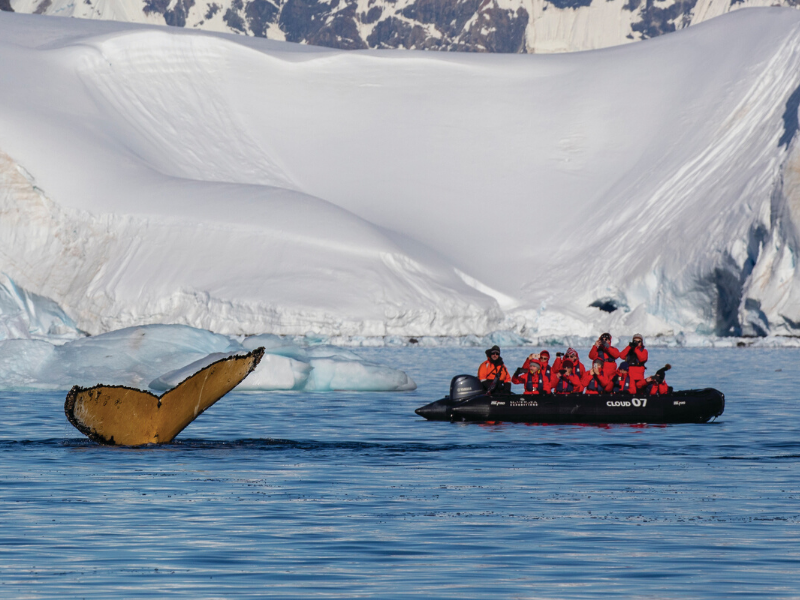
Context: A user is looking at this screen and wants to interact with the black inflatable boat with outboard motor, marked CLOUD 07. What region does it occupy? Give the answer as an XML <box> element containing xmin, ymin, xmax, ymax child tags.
<box><xmin>415</xmin><ymin>375</ymin><xmax>725</xmax><ymax>424</ymax></box>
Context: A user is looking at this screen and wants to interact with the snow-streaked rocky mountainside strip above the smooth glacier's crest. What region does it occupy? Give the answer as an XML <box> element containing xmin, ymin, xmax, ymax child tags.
<box><xmin>10</xmin><ymin>0</ymin><xmax>800</xmax><ymax>52</ymax></box>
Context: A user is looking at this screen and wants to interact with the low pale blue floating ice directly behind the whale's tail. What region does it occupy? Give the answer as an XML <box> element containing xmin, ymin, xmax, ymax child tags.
<box><xmin>0</xmin><ymin>325</ymin><xmax>416</xmax><ymax>392</ymax></box>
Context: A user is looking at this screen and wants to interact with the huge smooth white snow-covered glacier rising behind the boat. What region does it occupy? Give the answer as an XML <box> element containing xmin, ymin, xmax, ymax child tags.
<box><xmin>0</xmin><ymin>8</ymin><xmax>800</xmax><ymax>339</ymax></box>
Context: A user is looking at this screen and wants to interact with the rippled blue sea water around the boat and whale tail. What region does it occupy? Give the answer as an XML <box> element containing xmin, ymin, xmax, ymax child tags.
<box><xmin>0</xmin><ymin>348</ymin><xmax>800</xmax><ymax>598</ymax></box>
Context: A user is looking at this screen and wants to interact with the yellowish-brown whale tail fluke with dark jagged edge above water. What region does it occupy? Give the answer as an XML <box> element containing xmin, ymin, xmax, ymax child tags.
<box><xmin>64</xmin><ymin>348</ymin><xmax>264</xmax><ymax>446</ymax></box>
